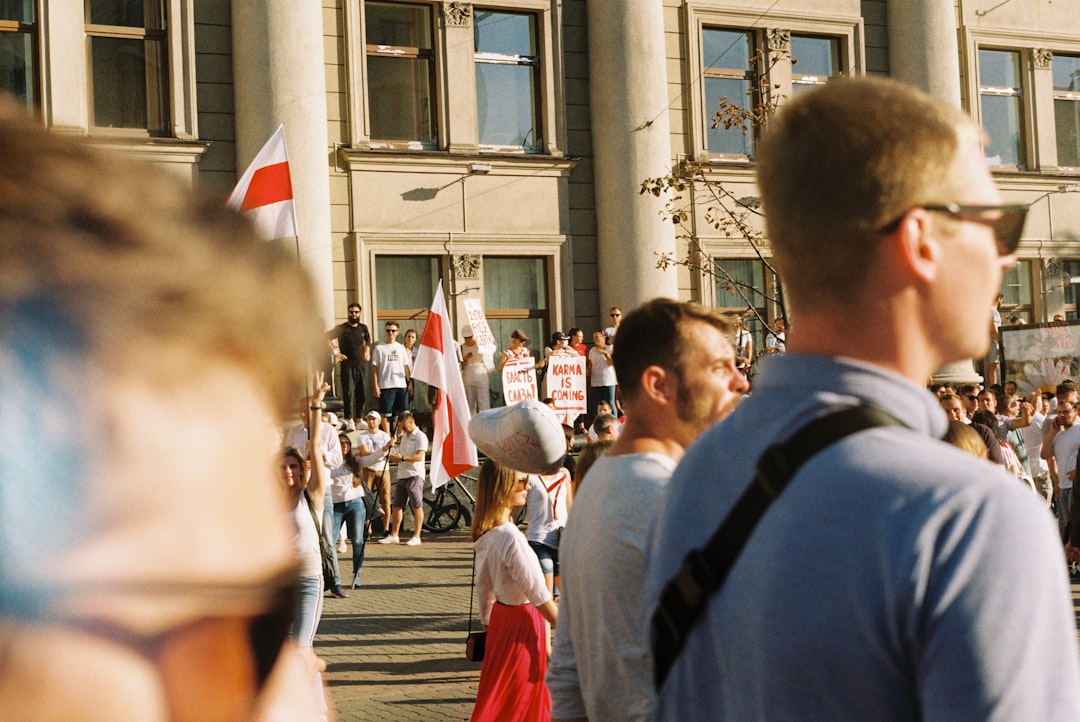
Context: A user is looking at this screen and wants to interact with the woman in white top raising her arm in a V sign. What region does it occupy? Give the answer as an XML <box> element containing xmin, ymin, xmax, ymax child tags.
<box><xmin>279</xmin><ymin>371</ymin><xmax>329</xmax><ymax>646</ymax></box>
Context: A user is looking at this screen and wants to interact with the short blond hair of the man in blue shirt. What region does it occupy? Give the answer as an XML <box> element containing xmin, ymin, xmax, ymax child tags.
<box><xmin>757</xmin><ymin>78</ymin><xmax>980</xmax><ymax>308</ymax></box>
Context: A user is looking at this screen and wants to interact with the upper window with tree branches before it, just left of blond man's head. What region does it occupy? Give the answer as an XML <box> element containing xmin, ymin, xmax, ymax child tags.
<box><xmin>701</xmin><ymin>28</ymin><xmax>757</xmax><ymax>156</ymax></box>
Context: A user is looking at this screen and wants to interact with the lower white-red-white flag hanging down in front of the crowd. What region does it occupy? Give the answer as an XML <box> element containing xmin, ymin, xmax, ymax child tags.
<box><xmin>413</xmin><ymin>281</ymin><xmax>478</xmax><ymax>489</ymax></box>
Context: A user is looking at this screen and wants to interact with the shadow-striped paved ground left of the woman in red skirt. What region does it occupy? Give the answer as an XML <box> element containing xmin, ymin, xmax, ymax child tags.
<box><xmin>315</xmin><ymin>529</ymin><xmax>480</xmax><ymax>722</ymax></box>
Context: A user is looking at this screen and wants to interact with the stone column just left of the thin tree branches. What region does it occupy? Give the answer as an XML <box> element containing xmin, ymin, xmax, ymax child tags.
<box><xmin>586</xmin><ymin>0</ymin><xmax>678</xmax><ymax>306</ymax></box>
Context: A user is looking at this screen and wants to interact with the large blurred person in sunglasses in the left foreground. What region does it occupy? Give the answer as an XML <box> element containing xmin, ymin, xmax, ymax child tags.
<box><xmin>0</xmin><ymin>105</ymin><xmax>323</xmax><ymax>722</ymax></box>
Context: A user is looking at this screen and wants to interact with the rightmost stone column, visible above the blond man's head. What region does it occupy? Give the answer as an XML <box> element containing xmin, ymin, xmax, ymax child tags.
<box><xmin>887</xmin><ymin>0</ymin><xmax>960</xmax><ymax>106</ymax></box>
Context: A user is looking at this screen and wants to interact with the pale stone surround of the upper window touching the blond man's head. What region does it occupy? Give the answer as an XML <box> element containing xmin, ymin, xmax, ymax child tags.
<box><xmin>672</xmin><ymin>0</ymin><xmax>865</xmax><ymax>165</ymax></box>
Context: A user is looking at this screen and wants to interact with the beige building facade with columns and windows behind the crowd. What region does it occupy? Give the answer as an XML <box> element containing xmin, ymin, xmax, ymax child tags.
<box><xmin>6</xmin><ymin>0</ymin><xmax>1080</xmax><ymax>360</ymax></box>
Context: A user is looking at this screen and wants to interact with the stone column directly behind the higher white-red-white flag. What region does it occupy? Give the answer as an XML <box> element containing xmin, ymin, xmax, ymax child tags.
<box><xmin>226</xmin><ymin>0</ymin><xmax>334</xmax><ymax>327</ymax></box>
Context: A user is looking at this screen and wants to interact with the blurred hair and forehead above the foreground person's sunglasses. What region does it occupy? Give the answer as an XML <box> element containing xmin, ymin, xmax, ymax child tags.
<box><xmin>0</xmin><ymin>104</ymin><xmax>318</xmax><ymax>631</ymax></box>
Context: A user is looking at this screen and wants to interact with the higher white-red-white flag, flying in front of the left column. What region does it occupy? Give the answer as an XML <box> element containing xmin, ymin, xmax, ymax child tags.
<box><xmin>227</xmin><ymin>125</ymin><xmax>298</xmax><ymax>241</ymax></box>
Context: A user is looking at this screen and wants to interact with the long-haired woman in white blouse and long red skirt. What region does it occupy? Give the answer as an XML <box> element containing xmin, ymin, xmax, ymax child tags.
<box><xmin>471</xmin><ymin>460</ymin><xmax>558</xmax><ymax>722</ymax></box>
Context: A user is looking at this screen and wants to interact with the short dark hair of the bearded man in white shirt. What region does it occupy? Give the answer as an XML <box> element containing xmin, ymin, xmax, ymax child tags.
<box><xmin>611</xmin><ymin>298</ymin><xmax>731</xmax><ymax>404</ymax></box>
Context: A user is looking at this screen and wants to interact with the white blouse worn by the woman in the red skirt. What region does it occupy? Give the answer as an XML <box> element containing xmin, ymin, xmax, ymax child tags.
<box><xmin>473</xmin><ymin>521</ymin><xmax>551</xmax><ymax>625</ymax></box>
